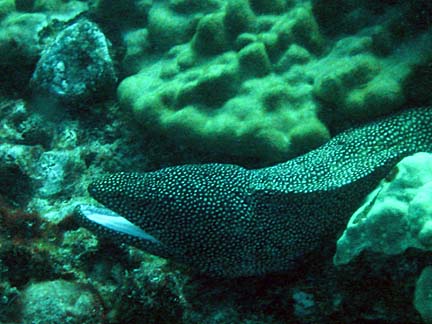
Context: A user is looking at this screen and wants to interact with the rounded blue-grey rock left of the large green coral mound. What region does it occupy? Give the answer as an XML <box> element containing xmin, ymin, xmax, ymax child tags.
<box><xmin>31</xmin><ymin>20</ymin><xmax>117</xmax><ymax>104</ymax></box>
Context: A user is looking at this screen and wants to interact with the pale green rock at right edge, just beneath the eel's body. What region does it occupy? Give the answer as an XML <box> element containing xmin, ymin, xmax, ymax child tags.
<box><xmin>334</xmin><ymin>153</ymin><xmax>432</xmax><ymax>265</ymax></box>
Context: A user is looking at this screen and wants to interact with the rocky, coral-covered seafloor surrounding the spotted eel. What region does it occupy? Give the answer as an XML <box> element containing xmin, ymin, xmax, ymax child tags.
<box><xmin>0</xmin><ymin>0</ymin><xmax>432</xmax><ymax>324</ymax></box>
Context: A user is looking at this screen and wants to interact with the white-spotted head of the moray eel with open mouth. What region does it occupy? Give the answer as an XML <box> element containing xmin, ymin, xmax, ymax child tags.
<box><xmin>75</xmin><ymin>164</ymin><xmax>251</xmax><ymax>274</ymax></box>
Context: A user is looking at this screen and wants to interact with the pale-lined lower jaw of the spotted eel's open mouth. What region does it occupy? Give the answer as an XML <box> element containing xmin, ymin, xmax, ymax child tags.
<box><xmin>75</xmin><ymin>204</ymin><xmax>161</xmax><ymax>244</ymax></box>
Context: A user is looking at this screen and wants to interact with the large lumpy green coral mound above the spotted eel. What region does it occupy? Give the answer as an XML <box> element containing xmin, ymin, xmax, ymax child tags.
<box><xmin>118</xmin><ymin>0</ymin><xmax>432</xmax><ymax>164</ymax></box>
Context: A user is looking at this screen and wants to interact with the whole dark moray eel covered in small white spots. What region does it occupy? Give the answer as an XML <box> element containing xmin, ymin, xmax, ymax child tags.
<box><xmin>75</xmin><ymin>107</ymin><xmax>432</xmax><ymax>277</ymax></box>
